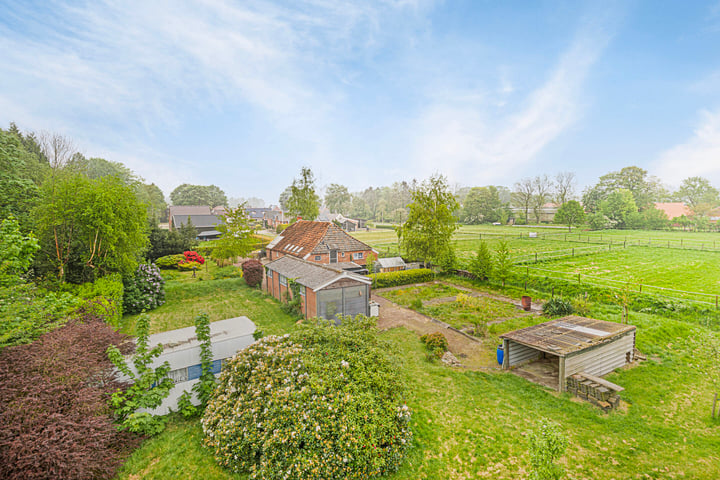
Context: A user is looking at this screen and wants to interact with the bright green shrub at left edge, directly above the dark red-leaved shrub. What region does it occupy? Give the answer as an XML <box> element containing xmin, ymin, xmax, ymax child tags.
<box><xmin>0</xmin><ymin>283</ymin><xmax>82</xmax><ymax>348</ymax></box>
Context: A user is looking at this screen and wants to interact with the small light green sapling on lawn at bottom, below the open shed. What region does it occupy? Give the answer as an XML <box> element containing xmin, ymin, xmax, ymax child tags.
<box><xmin>528</xmin><ymin>419</ymin><xmax>568</xmax><ymax>480</ymax></box>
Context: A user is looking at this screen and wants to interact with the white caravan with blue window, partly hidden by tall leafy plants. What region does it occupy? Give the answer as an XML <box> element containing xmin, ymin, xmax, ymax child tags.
<box><xmin>136</xmin><ymin>317</ymin><xmax>255</xmax><ymax>415</ymax></box>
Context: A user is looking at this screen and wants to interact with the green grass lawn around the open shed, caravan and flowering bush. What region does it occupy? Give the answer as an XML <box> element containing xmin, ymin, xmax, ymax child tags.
<box><xmin>117</xmin><ymin>269</ymin><xmax>720</xmax><ymax>480</ymax></box>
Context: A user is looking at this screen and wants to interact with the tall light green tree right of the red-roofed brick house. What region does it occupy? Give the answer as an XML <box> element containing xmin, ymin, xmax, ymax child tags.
<box><xmin>398</xmin><ymin>175</ymin><xmax>459</xmax><ymax>267</ymax></box>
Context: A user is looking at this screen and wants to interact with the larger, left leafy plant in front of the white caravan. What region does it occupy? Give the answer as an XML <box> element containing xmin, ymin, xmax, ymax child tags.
<box><xmin>107</xmin><ymin>314</ymin><xmax>174</xmax><ymax>436</ymax></box>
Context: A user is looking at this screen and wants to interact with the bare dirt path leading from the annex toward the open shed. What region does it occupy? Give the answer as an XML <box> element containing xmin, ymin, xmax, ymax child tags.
<box><xmin>372</xmin><ymin>292</ymin><xmax>499</xmax><ymax>370</ymax></box>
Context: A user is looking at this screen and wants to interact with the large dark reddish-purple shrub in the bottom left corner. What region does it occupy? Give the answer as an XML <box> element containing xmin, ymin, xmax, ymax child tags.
<box><xmin>0</xmin><ymin>304</ymin><xmax>140</xmax><ymax>480</ymax></box>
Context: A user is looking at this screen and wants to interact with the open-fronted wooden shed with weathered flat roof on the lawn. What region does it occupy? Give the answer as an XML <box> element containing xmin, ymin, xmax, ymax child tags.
<box><xmin>500</xmin><ymin>315</ymin><xmax>635</xmax><ymax>391</ymax></box>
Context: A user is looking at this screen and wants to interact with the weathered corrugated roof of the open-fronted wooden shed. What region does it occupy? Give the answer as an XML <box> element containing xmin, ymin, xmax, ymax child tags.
<box><xmin>500</xmin><ymin>315</ymin><xmax>635</xmax><ymax>357</ymax></box>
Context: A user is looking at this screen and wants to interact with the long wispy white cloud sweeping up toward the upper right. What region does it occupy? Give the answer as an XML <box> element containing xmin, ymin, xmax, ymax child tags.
<box><xmin>415</xmin><ymin>14</ymin><xmax>610</xmax><ymax>185</ymax></box>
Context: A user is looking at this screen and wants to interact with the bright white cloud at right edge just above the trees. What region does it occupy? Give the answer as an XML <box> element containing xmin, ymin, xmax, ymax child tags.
<box><xmin>655</xmin><ymin>110</ymin><xmax>720</xmax><ymax>186</ymax></box>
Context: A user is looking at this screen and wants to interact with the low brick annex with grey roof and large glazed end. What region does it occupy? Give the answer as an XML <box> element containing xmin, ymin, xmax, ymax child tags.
<box><xmin>265</xmin><ymin>255</ymin><xmax>371</xmax><ymax>320</ymax></box>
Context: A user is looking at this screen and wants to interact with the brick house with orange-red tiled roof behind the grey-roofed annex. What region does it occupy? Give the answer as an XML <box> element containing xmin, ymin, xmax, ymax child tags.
<box><xmin>266</xmin><ymin>220</ymin><xmax>377</xmax><ymax>271</ymax></box>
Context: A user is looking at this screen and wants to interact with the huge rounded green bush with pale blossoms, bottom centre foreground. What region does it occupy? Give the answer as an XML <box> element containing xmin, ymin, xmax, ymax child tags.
<box><xmin>202</xmin><ymin>316</ymin><xmax>412</xmax><ymax>479</ymax></box>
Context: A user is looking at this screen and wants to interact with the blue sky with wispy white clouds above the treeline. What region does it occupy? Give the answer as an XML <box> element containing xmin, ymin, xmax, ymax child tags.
<box><xmin>0</xmin><ymin>0</ymin><xmax>720</xmax><ymax>203</ymax></box>
